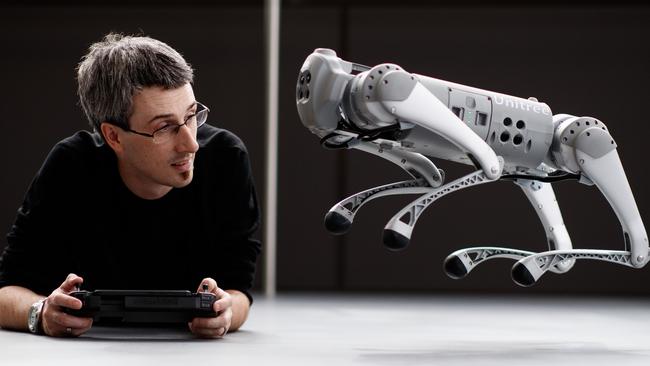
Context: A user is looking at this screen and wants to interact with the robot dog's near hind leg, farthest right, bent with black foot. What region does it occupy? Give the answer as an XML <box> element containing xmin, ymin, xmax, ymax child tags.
<box><xmin>512</xmin><ymin>117</ymin><xmax>649</xmax><ymax>286</ymax></box>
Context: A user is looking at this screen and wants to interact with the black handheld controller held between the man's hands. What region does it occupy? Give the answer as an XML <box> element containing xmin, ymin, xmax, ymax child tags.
<box><xmin>63</xmin><ymin>290</ymin><xmax>217</xmax><ymax>325</ymax></box>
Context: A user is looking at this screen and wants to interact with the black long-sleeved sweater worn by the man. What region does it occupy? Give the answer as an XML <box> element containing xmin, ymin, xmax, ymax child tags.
<box><xmin>0</xmin><ymin>125</ymin><xmax>260</xmax><ymax>300</ymax></box>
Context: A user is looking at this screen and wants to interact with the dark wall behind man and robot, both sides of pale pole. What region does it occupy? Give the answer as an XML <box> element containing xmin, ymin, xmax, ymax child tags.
<box><xmin>0</xmin><ymin>1</ymin><xmax>650</xmax><ymax>295</ymax></box>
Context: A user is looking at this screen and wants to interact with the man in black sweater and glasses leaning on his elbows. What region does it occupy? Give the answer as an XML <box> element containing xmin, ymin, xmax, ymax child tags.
<box><xmin>0</xmin><ymin>34</ymin><xmax>260</xmax><ymax>338</ymax></box>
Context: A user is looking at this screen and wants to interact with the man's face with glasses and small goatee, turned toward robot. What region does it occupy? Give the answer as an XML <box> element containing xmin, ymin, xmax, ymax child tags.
<box><xmin>118</xmin><ymin>84</ymin><xmax>199</xmax><ymax>199</ymax></box>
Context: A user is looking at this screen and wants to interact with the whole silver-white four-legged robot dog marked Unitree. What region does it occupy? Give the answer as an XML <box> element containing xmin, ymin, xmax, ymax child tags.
<box><xmin>296</xmin><ymin>48</ymin><xmax>649</xmax><ymax>286</ymax></box>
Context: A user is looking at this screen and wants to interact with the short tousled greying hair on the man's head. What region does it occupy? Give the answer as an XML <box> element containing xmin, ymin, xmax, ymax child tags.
<box><xmin>77</xmin><ymin>33</ymin><xmax>194</xmax><ymax>134</ymax></box>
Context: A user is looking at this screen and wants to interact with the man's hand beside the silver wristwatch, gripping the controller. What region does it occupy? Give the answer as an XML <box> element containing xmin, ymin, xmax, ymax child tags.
<box><xmin>41</xmin><ymin>273</ymin><xmax>93</xmax><ymax>337</ymax></box>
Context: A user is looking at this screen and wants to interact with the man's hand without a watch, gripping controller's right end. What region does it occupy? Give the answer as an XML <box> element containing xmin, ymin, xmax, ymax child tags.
<box><xmin>187</xmin><ymin>278</ymin><xmax>232</xmax><ymax>338</ymax></box>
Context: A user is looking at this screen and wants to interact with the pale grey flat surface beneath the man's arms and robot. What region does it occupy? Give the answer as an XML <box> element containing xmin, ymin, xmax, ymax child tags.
<box><xmin>0</xmin><ymin>294</ymin><xmax>650</xmax><ymax>366</ymax></box>
